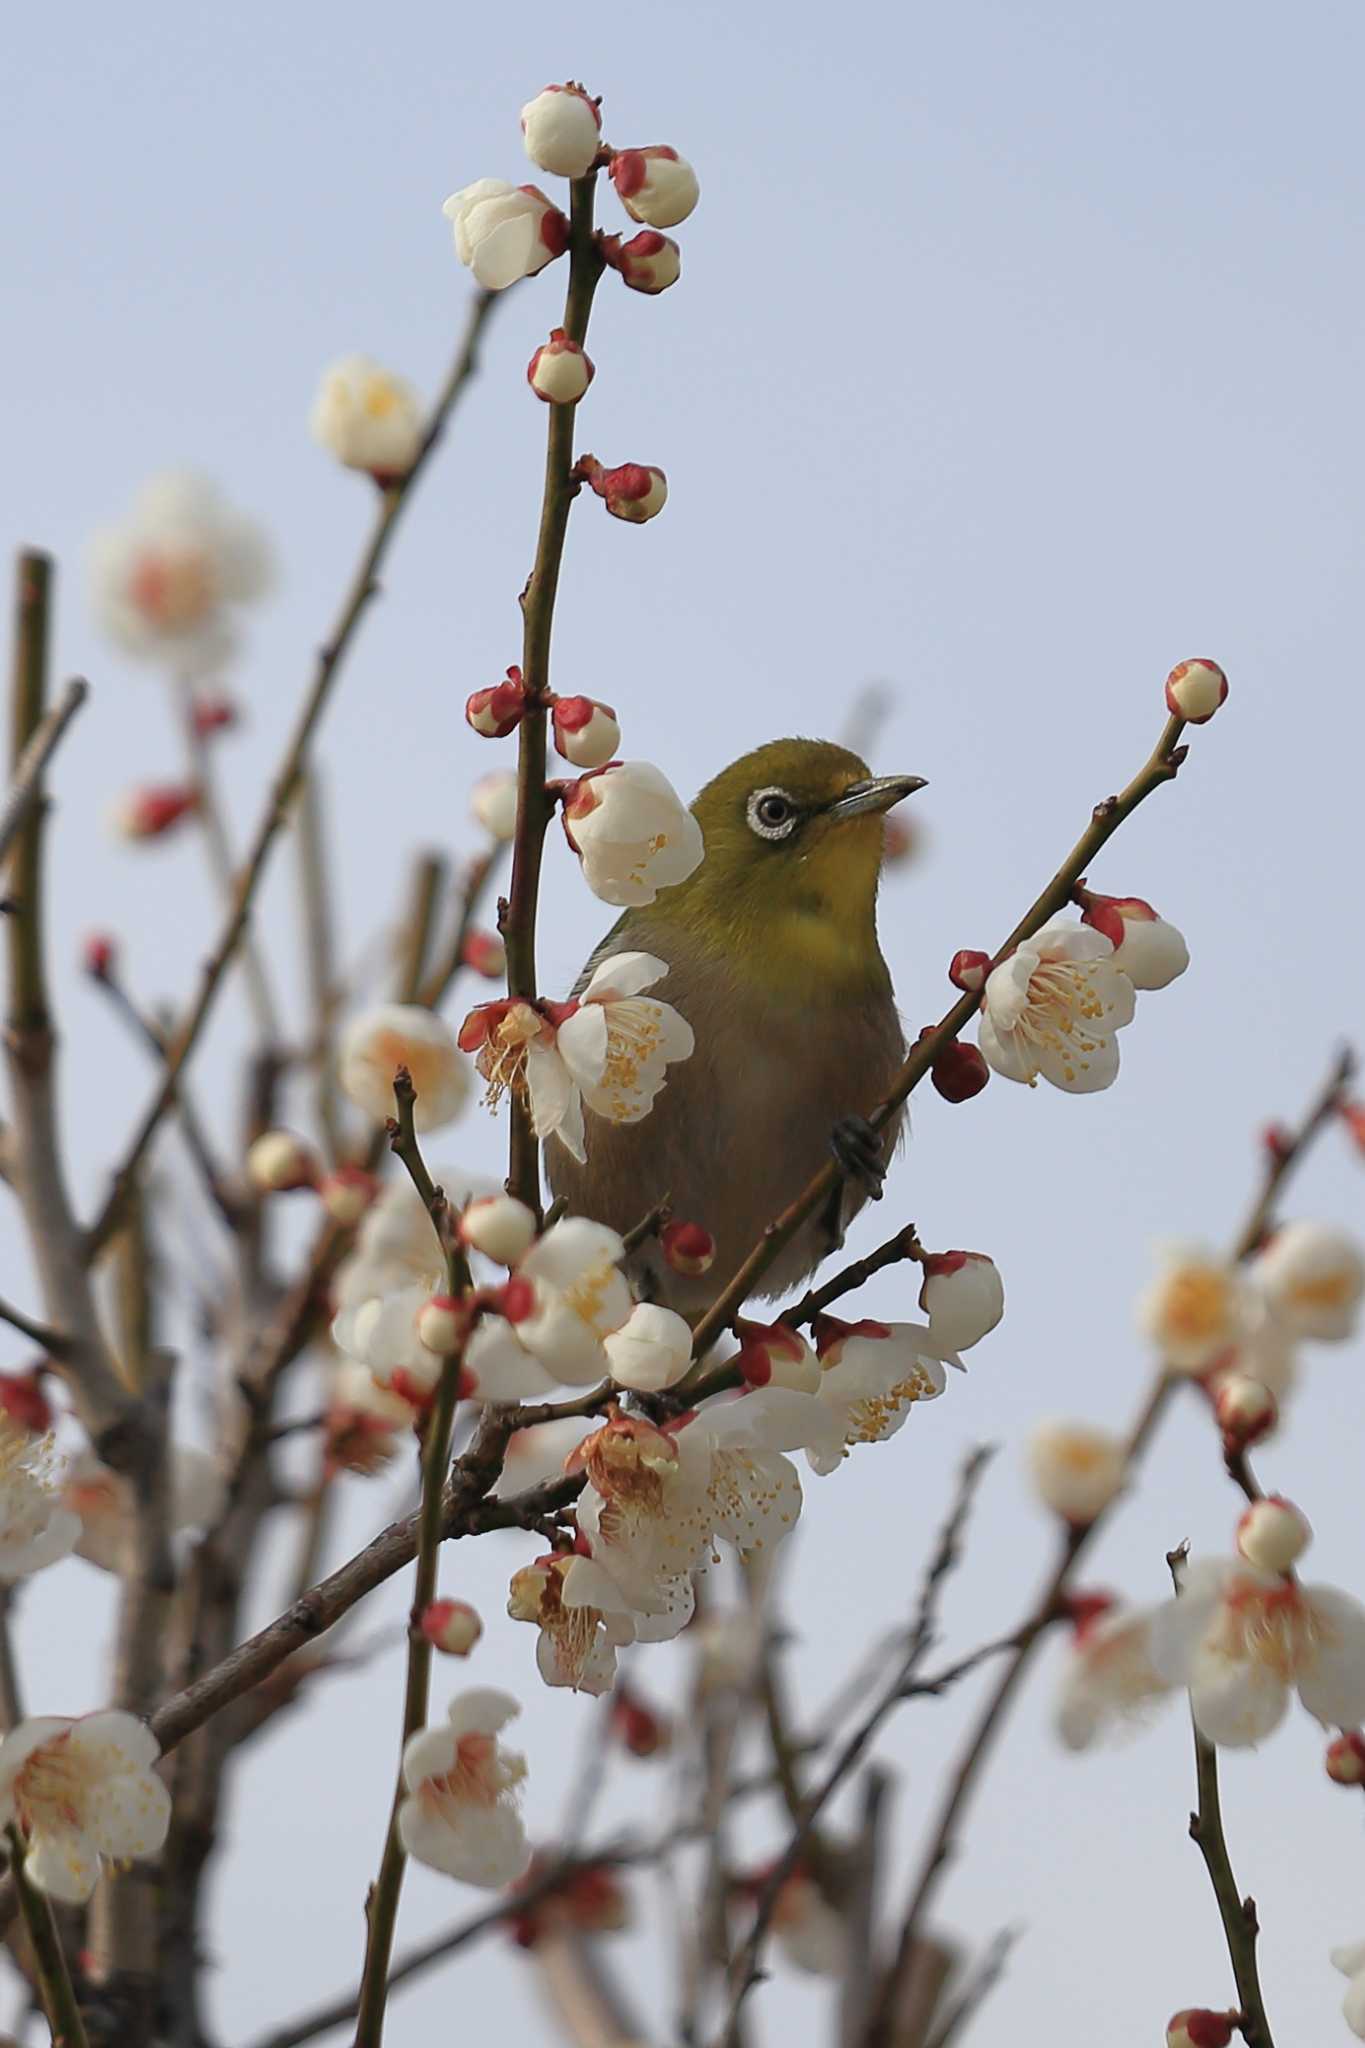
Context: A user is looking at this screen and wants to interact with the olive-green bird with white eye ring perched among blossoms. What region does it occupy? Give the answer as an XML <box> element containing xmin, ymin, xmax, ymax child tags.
<box><xmin>546</xmin><ymin>739</ymin><xmax>925</xmax><ymax>1317</ymax></box>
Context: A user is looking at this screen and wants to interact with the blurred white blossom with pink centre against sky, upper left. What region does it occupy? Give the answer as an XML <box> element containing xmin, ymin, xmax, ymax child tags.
<box><xmin>90</xmin><ymin>473</ymin><xmax>270</xmax><ymax>674</ymax></box>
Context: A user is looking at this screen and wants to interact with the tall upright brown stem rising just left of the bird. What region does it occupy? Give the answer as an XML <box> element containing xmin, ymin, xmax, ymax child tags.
<box><xmin>501</xmin><ymin>170</ymin><xmax>604</xmax><ymax>1214</ymax></box>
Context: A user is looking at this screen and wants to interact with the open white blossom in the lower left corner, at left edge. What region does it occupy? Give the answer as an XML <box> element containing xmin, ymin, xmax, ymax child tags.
<box><xmin>0</xmin><ymin>1710</ymin><xmax>170</xmax><ymax>1905</ymax></box>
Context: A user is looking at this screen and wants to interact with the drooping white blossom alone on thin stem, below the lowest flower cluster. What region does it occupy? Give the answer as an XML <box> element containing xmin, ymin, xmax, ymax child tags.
<box><xmin>397</xmin><ymin>1686</ymin><xmax>530</xmax><ymax>1890</ymax></box>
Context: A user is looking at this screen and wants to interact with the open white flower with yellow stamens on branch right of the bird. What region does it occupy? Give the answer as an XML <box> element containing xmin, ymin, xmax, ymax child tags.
<box><xmin>978</xmin><ymin>918</ymin><xmax>1136</xmax><ymax>1096</ymax></box>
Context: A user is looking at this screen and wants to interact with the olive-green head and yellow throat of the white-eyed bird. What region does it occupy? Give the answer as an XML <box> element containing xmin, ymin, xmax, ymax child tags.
<box><xmin>655</xmin><ymin>739</ymin><xmax>923</xmax><ymax>999</ymax></box>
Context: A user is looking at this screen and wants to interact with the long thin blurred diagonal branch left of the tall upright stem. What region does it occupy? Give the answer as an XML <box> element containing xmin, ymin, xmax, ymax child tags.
<box><xmin>90</xmin><ymin>293</ymin><xmax>493</xmax><ymax>1251</ymax></box>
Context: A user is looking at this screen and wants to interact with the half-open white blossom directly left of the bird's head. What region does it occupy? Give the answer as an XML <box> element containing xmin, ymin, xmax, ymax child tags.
<box><xmin>563</xmin><ymin>762</ymin><xmax>704</xmax><ymax>909</ymax></box>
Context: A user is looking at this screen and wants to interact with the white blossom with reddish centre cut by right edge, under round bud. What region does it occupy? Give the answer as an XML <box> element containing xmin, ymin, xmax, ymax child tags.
<box><xmin>1152</xmin><ymin>1559</ymin><xmax>1365</xmax><ymax>1749</ymax></box>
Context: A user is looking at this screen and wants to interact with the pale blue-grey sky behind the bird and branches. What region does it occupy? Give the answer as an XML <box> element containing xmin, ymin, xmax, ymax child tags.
<box><xmin>0</xmin><ymin>0</ymin><xmax>1365</xmax><ymax>2048</ymax></box>
